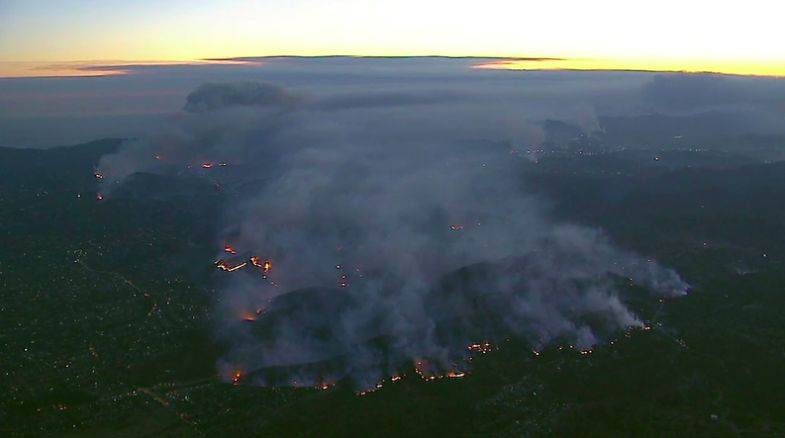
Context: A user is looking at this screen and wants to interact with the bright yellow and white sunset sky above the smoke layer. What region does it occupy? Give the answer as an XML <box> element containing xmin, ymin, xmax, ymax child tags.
<box><xmin>0</xmin><ymin>0</ymin><xmax>785</xmax><ymax>77</ymax></box>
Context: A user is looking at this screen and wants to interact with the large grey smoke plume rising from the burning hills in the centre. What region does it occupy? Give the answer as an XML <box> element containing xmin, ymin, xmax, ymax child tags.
<box><xmin>100</xmin><ymin>77</ymin><xmax>687</xmax><ymax>388</ymax></box>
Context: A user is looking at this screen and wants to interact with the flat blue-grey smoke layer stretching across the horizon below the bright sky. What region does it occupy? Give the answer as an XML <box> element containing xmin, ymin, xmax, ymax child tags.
<box><xmin>6</xmin><ymin>57</ymin><xmax>785</xmax><ymax>146</ymax></box>
